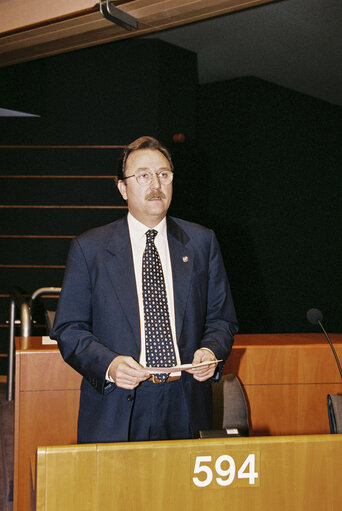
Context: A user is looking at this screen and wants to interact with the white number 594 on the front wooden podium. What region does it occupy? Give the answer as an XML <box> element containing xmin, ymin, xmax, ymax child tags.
<box><xmin>192</xmin><ymin>453</ymin><xmax>259</xmax><ymax>488</ymax></box>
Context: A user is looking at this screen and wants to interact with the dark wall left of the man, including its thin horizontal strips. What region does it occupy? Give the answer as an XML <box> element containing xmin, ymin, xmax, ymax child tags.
<box><xmin>0</xmin><ymin>40</ymin><xmax>198</xmax><ymax>374</ymax></box>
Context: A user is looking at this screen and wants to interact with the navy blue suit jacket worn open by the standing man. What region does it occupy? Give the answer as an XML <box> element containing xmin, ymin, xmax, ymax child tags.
<box><xmin>50</xmin><ymin>217</ymin><xmax>237</xmax><ymax>443</ymax></box>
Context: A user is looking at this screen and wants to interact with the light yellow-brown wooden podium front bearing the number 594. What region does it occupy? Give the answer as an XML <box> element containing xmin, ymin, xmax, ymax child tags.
<box><xmin>33</xmin><ymin>435</ymin><xmax>342</xmax><ymax>511</ymax></box>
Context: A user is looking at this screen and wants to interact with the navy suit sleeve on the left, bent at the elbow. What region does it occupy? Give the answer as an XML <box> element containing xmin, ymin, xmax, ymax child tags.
<box><xmin>50</xmin><ymin>239</ymin><xmax>118</xmax><ymax>392</ymax></box>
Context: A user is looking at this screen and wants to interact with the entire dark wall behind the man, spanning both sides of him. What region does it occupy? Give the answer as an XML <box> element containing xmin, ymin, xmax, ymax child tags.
<box><xmin>0</xmin><ymin>36</ymin><xmax>342</xmax><ymax>372</ymax></box>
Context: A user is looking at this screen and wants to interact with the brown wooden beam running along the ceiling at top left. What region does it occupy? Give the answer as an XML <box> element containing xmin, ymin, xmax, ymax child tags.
<box><xmin>0</xmin><ymin>0</ymin><xmax>274</xmax><ymax>66</ymax></box>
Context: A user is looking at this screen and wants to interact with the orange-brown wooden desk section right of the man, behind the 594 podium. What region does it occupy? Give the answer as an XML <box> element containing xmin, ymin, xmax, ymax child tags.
<box><xmin>224</xmin><ymin>334</ymin><xmax>342</xmax><ymax>435</ymax></box>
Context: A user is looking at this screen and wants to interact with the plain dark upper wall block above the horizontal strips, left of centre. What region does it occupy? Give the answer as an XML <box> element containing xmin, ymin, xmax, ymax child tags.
<box><xmin>0</xmin><ymin>40</ymin><xmax>197</xmax><ymax>144</ymax></box>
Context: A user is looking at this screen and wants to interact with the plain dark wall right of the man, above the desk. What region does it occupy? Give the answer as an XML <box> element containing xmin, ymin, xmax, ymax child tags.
<box><xmin>198</xmin><ymin>78</ymin><xmax>342</xmax><ymax>332</ymax></box>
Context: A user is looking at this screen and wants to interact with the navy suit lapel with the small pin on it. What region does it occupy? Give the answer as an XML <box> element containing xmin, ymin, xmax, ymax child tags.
<box><xmin>167</xmin><ymin>217</ymin><xmax>194</xmax><ymax>343</ymax></box>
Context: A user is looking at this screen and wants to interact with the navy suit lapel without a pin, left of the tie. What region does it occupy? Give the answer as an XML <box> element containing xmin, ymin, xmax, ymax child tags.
<box><xmin>106</xmin><ymin>217</ymin><xmax>140</xmax><ymax>352</ymax></box>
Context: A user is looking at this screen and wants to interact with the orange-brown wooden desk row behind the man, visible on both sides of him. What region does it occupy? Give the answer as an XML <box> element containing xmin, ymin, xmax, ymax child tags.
<box><xmin>13</xmin><ymin>334</ymin><xmax>342</xmax><ymax>511</ymax></box>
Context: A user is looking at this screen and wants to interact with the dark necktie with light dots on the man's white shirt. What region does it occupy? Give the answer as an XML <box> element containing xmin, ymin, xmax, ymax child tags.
<box><xmin>142</xmin><ymin>229</ymin><xmax>176</xmax><ymax>382</ymax></box>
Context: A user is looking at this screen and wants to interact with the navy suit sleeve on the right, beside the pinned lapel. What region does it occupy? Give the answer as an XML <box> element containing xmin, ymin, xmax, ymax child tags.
<box><xmin>201</xmin><ymin>231</ymin><xmax>238</xmax><ymax>380</ymax></box>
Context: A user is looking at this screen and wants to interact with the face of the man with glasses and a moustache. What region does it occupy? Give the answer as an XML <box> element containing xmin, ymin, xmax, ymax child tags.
<box><xmin>118</xmin><ymin>149</ymin><xmax>172</xmax><ymax>228</ymax></box>
